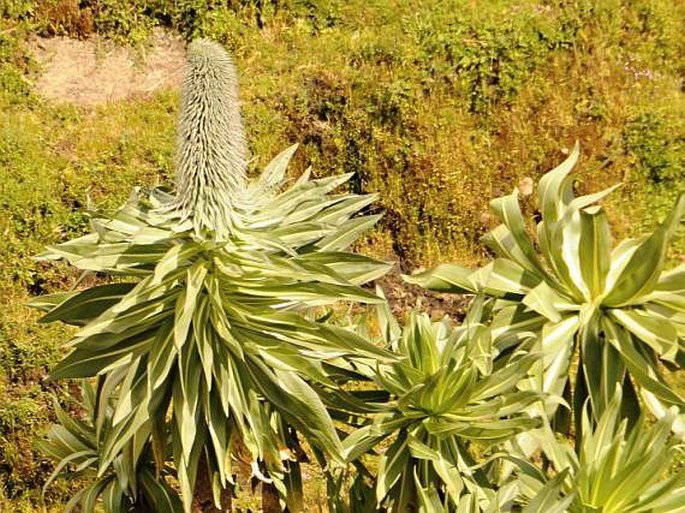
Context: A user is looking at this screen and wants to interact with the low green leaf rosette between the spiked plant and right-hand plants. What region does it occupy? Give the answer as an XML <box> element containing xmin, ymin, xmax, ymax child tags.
<box><xmin>340</xmin><ymin>304</ymin><xmax>541</xmax><ymax>512</ymax></box>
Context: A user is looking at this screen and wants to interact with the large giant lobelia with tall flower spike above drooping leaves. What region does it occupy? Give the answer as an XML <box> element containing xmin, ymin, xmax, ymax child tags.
<box><xmin>33</xmin><ymin>41</ymin><xmax>388</xmax><ymax>511</ymax></box>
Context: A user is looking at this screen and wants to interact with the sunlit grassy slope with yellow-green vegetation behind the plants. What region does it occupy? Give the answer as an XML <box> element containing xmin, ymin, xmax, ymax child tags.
<box><xmin>0</xmin><ymin>0</ymin><xmax>685</xmax><ymax>511</ymax></box>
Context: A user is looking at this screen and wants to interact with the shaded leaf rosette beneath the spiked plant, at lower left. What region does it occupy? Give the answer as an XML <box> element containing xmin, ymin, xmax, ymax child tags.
<box><xmin>38</xmin><ymin>383</ymin><xmax>183</xmax><ymax>513</ymax></box>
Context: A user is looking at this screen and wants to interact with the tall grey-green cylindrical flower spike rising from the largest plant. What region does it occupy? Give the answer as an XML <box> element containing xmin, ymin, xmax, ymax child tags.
<box><xmin>176</xmin><ymin>39</ymin><xmax>247</xmax><ymax>239</ymax></box>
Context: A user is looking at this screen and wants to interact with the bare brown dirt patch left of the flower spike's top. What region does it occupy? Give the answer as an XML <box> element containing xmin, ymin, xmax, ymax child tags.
<box><xmin>29</xmin><ymin>30</ymin><xmax>185</xmax><ymax>106</ymax></box>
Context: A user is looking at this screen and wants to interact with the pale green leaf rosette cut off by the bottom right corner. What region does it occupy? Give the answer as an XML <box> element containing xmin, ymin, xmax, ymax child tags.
<box><xmin>522</xmin><ymin>388</ymin><xmax>685</xmax><ymax>513</ymax></box>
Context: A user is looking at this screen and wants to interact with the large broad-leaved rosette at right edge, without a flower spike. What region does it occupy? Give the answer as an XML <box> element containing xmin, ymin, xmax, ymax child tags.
<box><xmin>406</xmin><ymin>144</ymin><xmax>685</xmax><ymax>429</ymax></box>
